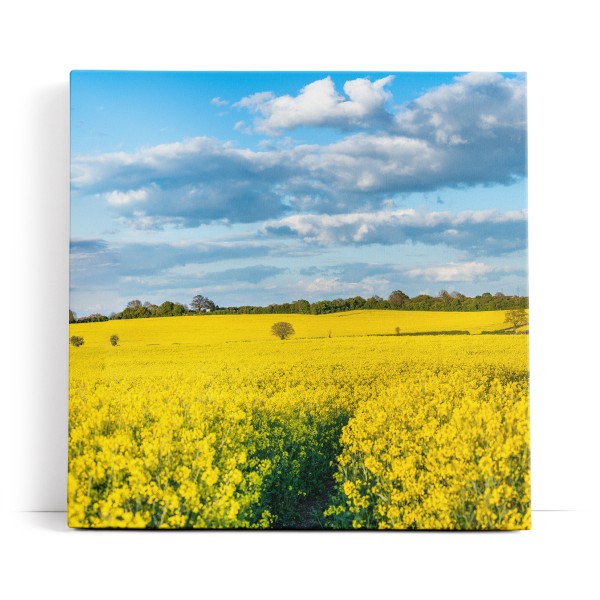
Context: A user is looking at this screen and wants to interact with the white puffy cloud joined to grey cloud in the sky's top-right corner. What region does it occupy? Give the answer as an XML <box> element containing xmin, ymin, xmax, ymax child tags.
<box><xmin>235</xmin><ymin>73</ymin><xmax>526</xmax><ymax>170</ymax></box>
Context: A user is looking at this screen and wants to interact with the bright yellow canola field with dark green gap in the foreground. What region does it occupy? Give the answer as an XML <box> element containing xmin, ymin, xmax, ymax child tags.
<box><xmin>68</xmin><ymin>311</ymin><xmax>531</xmax><ymax>529</ymax></box>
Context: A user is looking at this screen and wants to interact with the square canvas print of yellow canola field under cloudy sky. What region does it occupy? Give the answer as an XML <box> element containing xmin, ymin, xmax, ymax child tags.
<box><xmin>68</xmin><ymin>71</ymin><xmax>531</xmax><ymax>530</ymax></box>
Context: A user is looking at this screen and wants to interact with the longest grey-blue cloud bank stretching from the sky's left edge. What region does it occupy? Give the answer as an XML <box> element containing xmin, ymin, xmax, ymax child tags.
<box><xmin>73</xmin><ymin>134</ymin><xmax>520</xmax><ymax>228</ymax></box>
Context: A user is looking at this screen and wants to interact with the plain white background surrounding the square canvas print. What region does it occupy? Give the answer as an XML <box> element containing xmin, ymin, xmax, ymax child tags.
<box><xmin>0</xmin><ymin>0</ymin><xmax>600</xmax><ymax>598</ymax></box>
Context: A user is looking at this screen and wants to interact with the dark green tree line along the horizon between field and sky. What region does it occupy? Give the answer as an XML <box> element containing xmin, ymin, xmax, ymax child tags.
<box><xmin>69</xmin><ymin>290</ymin><xmax>529</xmax><ymax>323</ymax></box>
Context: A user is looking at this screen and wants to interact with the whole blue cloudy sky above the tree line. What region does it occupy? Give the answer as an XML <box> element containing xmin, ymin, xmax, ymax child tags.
<box><xmin>71</xmin><ymin>71</ymin><xmax>527</xmax><ymax>316</ymax></box>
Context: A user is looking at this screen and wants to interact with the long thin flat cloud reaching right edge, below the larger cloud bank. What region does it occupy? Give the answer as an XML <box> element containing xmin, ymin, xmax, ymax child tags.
<box><xmin>263</xmin><ymin>209</ymin><xmax>527</xmax><ymax>254</ymax></box>
